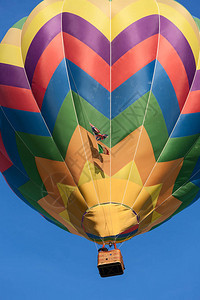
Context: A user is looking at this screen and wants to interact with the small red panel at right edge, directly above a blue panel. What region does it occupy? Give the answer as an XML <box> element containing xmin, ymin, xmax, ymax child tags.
<box><xmin>182</xmin><ymin>91</ymin><xmax>200</xmax><ymax>114</ymax></box>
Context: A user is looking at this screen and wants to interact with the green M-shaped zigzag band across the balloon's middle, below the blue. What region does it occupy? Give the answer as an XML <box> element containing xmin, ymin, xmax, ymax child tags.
<box><xmin>53</xmin><ymin>92</ymin><xmax>168</xmax><ymax>151</ymax></box>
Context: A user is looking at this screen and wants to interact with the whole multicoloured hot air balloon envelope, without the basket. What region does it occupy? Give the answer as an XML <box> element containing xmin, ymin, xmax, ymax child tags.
<box><xmin>0</xmin><ymin>0</ymin><xmax>200</xmax><ymax>243</ymax></box>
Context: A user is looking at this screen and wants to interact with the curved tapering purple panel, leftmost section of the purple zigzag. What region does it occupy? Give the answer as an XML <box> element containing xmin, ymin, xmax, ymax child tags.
<box><xmin>25</xmin><ymin>14</ymin><xmax>61</xmax><ymax>84</ymax></box>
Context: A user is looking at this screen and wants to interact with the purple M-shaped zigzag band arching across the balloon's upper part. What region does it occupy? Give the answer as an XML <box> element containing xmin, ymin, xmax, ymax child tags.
<box><xmin>25</xmin><ymin>13</ymin><xmax>196</xmax><ymax>92</ymax></box>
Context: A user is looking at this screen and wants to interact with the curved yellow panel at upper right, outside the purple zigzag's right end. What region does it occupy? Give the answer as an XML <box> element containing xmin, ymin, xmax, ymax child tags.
<box><xmin>159</xmin><ymin>3</ymin><xmax>200</xmax><ymax>64</ymax></box>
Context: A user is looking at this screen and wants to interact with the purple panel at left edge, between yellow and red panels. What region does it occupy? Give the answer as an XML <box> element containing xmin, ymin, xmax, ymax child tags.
<box><xmin>0</xmin><ymin>63</ymin><xmax>30</xmax><ymax>89</ymax></box>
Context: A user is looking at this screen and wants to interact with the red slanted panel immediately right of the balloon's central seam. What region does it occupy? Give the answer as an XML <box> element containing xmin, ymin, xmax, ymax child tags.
<box><xmin>112</xmin><ymin>35</ymin><xmax>158</xmax><ymax>91</ymax></box>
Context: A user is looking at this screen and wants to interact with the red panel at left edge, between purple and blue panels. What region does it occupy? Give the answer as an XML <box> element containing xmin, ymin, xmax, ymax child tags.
<box><xmin>0</xmin><ymin>85</ymin><xmax>39</xmax><ymax>112</ymax></box>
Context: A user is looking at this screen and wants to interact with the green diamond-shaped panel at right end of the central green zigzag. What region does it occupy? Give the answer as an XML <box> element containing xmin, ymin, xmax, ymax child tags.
<box><xmin>144</xmin><ymin>93</ymin><xmax>169</xmax><ymax>160</ymax></box>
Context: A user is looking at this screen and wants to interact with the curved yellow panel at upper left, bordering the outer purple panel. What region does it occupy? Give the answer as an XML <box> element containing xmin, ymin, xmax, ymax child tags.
<box><xmin>22</xmin><ymin>1</ymin><xmax>63</xmax><ymax>61</ymax></box>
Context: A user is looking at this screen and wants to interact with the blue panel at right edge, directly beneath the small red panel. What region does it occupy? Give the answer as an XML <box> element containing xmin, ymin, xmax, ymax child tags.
<box><xmin>172</xmin><ymin>112</ymin><xmax>200</xmax><ymax>137</ymax></box>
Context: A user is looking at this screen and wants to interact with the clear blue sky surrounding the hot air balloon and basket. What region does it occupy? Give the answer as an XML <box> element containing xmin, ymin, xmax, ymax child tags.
<box><xmin>0</xmin><ymin>0</ymin><xmax>200</xmax><ymax>300</ymax></box>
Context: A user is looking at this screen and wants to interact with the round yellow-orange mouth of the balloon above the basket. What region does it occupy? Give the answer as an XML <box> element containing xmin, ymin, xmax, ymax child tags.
<box><xmin>81</xmin><ymin>202</ymin><xmax>139</xmax><ymax>243</ymax></box>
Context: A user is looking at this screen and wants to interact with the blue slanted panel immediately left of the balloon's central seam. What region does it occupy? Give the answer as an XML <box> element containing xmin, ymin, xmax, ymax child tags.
<box><xmin>67</xmin><ymin>60</ymin><xmax>110</xmax><ymax>118</ymax></box>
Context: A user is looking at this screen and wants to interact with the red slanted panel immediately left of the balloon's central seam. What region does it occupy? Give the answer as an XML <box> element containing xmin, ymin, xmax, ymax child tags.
<box><xmin>63</xmin><ymin>33</ymin><xmax>110</xmax><ymax>91</ymax></box>
